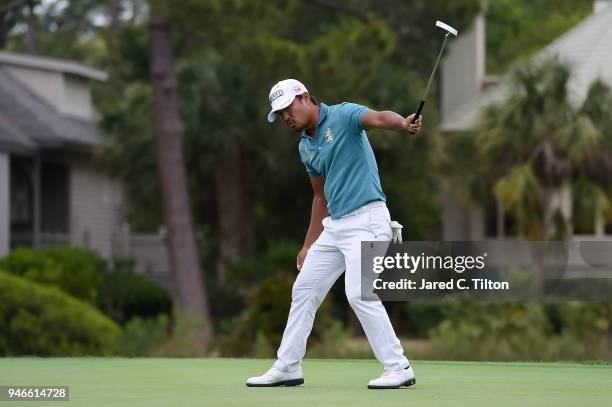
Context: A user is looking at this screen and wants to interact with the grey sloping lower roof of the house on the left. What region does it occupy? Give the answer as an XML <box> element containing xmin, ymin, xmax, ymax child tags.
<box><xmin>0</xmin><ymin>67</ymin><xmax>99</xmax><ymax>151</ymax></box>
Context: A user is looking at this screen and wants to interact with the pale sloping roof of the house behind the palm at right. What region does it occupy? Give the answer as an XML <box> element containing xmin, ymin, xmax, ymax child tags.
<box><xmin>440</xmin><ymin>5</ymin><xmax>612</xmax><ymax>131</ymax></box>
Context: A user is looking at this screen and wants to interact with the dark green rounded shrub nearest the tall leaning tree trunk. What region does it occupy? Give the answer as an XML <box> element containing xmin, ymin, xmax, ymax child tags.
<box><xmin>98</xmin><ymin>271</ymin><xmax>172</xmax><ymax>324</ymax></box>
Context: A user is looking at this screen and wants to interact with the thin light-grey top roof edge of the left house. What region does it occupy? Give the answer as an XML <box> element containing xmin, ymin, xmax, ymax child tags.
<box><xmin>0</xmin><ymin>51</ymin><xmax>108</xmax><ymax>81</ymax></box>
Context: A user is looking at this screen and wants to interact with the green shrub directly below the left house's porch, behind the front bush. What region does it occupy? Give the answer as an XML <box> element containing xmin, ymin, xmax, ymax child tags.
<box><xmin>0</xmin><ymin>247</ymin><xmax>104</xmax><ymax>304</ymax></box>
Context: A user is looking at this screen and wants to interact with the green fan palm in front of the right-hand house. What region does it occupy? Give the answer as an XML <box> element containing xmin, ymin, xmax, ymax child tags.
<box><xmin>475</xmin><ymin>59</ymin><xmax>612</xmax><ymax>239</ymax></box>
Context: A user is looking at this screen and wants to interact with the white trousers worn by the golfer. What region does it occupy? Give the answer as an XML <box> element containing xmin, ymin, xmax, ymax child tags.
<box><xmin>274</xmin><ymin>202</ymin><xmax>409</xmax><ymax>372</ymax></box>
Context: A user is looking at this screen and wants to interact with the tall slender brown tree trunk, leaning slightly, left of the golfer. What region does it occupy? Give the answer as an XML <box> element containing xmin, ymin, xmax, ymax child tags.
<box><xmin>150</xmin><ymin>22</ymin><xmax>212</xmax><ymax>345</ymax></box>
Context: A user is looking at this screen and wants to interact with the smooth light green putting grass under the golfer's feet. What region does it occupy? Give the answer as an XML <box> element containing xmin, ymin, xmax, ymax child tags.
<box><xmin>0</xmin><ymin>358</ymin><xmax>612</xmax><ymax>407</ymax></box>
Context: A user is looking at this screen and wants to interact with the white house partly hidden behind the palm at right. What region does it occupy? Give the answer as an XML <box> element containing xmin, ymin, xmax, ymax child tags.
<box><xmin>441</xmin><ymin>0</ymin><xmax>612</xmax><ymax>240</ymax></box>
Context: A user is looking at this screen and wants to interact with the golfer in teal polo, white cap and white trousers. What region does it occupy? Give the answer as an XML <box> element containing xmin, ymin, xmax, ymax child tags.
<box><xmin>246</xmin><ymin>79</ymin><xmax>421</xmax><ymax>389</ymax></box>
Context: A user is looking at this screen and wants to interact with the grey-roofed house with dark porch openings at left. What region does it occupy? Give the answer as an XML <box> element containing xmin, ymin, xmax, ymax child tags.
<box><xmin>0</xmin><ymin>52</ymin><xmax>125</xmax><ymax>259</ymax></box>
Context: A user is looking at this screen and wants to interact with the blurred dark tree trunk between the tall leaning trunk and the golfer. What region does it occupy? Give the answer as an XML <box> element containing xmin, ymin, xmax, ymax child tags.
<box><xmin>215</xmin><ymin>148</ymin><xmax>255</xmax><ymax>284</ymax></box>
